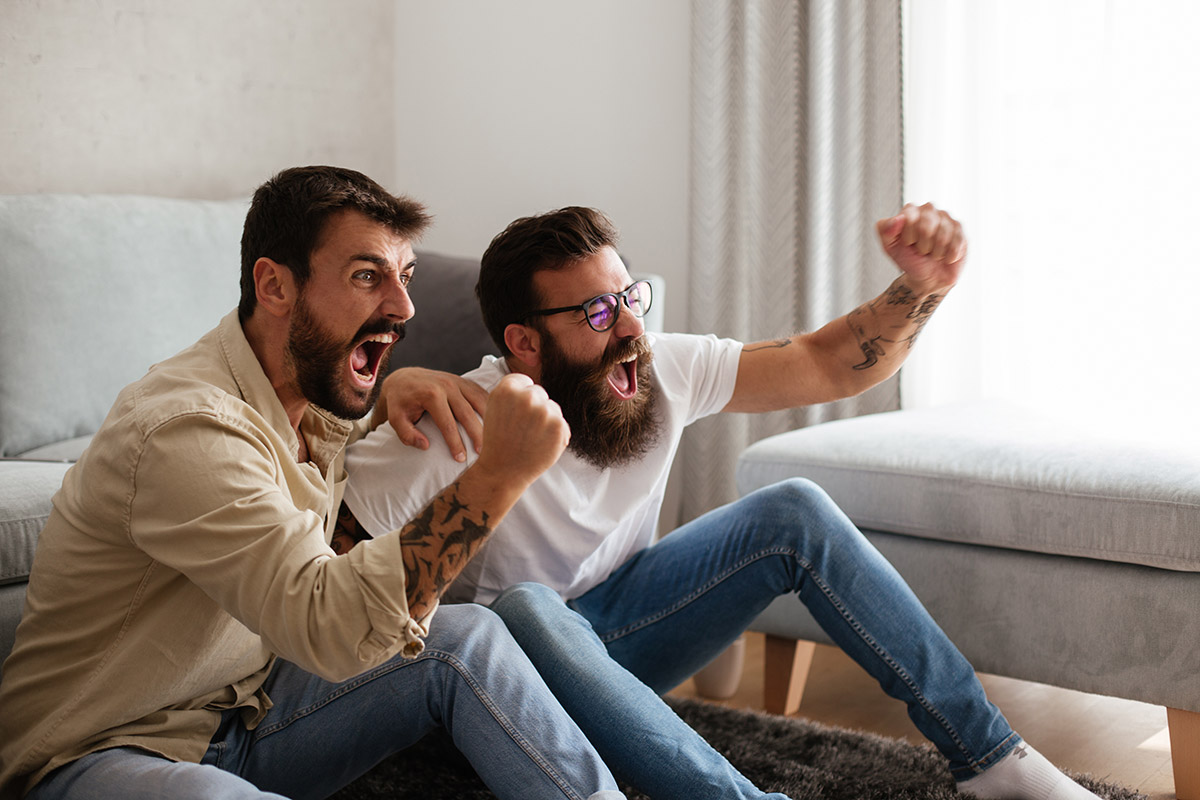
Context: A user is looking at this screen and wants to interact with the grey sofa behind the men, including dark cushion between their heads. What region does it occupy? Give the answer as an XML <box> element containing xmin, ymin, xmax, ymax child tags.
<box><xmin>0</xmin><ymin>194</ymin><xmax>494</xmax><ymax>676</ymax></box>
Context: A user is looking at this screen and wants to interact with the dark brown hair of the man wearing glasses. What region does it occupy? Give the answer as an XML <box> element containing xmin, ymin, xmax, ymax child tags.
<box><xmin>475</xmin><ymin>205</ymin><xmax>618</xmax><ymax>355</ymax></box>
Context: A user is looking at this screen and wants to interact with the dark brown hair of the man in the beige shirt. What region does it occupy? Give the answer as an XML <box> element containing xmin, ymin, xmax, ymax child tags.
<box><xmin>238</xmin><ymin>167</ymin><xmax>432</xmax><ymax>321</ymax></box>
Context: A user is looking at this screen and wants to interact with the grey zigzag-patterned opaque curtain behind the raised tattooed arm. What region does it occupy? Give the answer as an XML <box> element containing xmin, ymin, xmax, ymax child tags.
<box><xmin>678</xmin><ymin>0</ymin><xmax>902</xmax><ymax>521</ymax></box>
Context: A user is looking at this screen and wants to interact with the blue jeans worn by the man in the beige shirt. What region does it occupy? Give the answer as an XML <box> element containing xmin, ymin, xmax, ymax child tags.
<box><xmin>29</xmin><ymin>606</ymin><xmax>624</xmax><ymax>800</ymax></box>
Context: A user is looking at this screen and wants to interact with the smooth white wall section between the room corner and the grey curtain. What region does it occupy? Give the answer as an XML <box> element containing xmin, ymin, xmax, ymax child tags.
<box><xmin>395</xmin><ymin>0</ymin><xmax>691</xmax><ymax>330</ymax></box>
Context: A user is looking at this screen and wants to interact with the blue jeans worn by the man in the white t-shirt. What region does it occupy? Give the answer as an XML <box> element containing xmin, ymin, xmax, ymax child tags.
<box><xmin>492</xmin><ymin>480</ymin><xmax>1020</xmax><ymax>798</ymax></box>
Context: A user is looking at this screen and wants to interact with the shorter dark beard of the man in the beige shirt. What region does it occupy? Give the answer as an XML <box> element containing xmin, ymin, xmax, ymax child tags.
<box><xmin>288</xmin><ymin>296</ymin><xmax>404</xmax><ymax>420</ymax></box>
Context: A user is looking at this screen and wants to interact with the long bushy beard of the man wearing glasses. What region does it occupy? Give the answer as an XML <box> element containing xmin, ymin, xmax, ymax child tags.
<box><xmin>541</xmin><ymin>336</ymin><xmax>661</xmax><ymax>469</ymax></box>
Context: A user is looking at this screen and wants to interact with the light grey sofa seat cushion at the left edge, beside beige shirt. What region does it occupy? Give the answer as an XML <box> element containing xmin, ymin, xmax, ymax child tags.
<box><xmin>0</xmin><ymin>461</ymin><xmax>71</xmax><ymax>585</ymax></box>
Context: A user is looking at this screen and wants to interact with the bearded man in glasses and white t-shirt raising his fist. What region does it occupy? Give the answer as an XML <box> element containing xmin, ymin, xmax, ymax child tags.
<box><xmin>344</xmin><ymin>204</ymin><xmax>1094</xmax><ymax>800</ymax></box>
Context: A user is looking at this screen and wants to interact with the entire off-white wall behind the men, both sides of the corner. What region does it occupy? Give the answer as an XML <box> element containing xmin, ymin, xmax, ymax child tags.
<box><xmin>0</xmin><ymin>0</ymin><xmax>691</xmax><ymax>330</ymax></box>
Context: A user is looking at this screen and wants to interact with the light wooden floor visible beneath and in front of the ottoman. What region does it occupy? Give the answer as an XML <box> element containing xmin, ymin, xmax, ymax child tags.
<box><xmin>671</xmin><ymin>633</ymin><xmax>1175</xmax><ymax>800</ymax></box>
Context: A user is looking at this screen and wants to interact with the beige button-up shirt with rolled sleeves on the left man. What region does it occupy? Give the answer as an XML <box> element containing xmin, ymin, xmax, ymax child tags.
<box><xmin>0</xmin><ymin>312</ymin><xmax>428</xmax><ymax>798</ymax></box>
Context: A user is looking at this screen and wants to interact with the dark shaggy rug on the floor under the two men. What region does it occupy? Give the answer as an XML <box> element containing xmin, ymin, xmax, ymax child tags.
<box><xmin>331</xmin><ymin>698</ymin><xmax>1144</xmax><ymax>800</ymax></box>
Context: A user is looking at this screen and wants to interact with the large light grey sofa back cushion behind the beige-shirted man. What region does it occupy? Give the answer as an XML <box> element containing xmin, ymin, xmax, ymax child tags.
<box><xmin>0</xmin><ymin>194</ymin><xmax>247</xmax><ymax>456</ymax></box>
